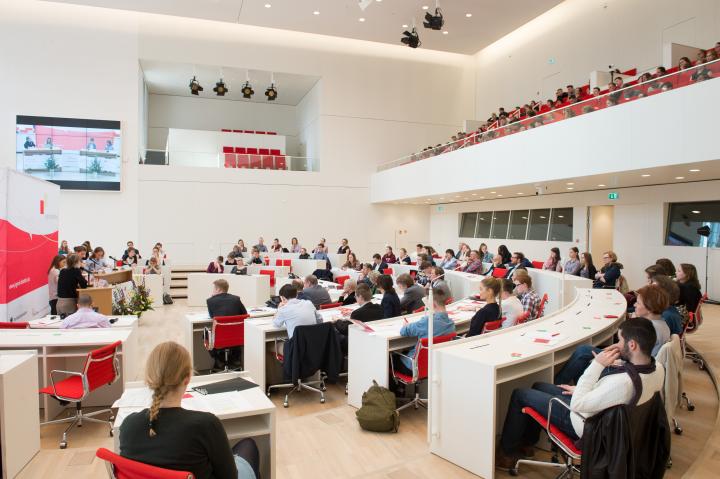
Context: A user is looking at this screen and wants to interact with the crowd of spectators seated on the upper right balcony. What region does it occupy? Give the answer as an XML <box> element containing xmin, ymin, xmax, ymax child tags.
<box><xmin>410</xmin><ymin>42</ymin><xmax>720</xmax><ymax>161</ymax></box>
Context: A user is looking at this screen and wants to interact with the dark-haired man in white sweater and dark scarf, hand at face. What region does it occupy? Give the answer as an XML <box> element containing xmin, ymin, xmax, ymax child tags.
<box><xmin>495</xmin><ymin>318</ymin><xmax>665</xmax><ymax>469</ymax></box>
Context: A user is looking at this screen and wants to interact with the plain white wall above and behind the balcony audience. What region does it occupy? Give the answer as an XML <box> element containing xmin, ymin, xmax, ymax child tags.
<box><xmin>476</xmin><ymin>0</ymin><xmax>720</xmax><ymax>115</ymax></box>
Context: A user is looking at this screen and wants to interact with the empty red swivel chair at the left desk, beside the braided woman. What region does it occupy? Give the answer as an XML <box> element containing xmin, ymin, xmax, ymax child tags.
<box><xmin>40</xmin><ymin>341</ymin><xmax>122</xmax><ymax>449</ymax></box>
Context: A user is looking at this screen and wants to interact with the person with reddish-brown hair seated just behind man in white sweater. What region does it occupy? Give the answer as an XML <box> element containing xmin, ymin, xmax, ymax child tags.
<box><xmin>555</xmin><ymin>285</ymin><xmax>670</xmax><ymax>384</ymax></box>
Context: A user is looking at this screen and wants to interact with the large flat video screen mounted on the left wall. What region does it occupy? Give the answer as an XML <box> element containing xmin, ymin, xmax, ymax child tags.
<box><xmin>15</xmin><ymin>115</ymin><xmax>122</xmax><ymax>191</ymax></box>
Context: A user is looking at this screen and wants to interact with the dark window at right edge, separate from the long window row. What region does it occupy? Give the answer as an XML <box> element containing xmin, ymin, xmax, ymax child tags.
<box><xmin>665</xmin><ymin>201</ymin><xmax>720</xmax><ymax>248</ymax></box>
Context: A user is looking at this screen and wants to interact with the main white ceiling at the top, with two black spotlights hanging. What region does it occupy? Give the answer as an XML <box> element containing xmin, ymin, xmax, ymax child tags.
<box><xmin>46</xmin><ymin>0</ymin><xmax>562</xmax><ymax>54</ymax></box>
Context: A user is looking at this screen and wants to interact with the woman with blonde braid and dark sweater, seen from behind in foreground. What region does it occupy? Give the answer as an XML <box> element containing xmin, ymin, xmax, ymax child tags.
<box><xmin>120</xmin><ymin>341</ymin><xmax>260</xmax><ymax>479</ymax></box>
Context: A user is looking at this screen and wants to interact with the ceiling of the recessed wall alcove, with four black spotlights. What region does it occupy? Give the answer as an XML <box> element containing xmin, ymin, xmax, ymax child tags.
<box><xmin>140</xmin><ymin>60</ymin><xmax>319</xmax><ymax>106</ymax></box>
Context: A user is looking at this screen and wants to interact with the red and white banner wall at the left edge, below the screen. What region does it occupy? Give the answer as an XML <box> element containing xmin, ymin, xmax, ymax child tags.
<box><xmin>0</xmin><ymin>168</ymin><xmax>60</xmax><ymax>321</ymax></box>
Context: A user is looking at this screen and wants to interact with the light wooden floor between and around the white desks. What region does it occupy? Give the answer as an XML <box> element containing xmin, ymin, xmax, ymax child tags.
<box><xmin>18</xmin><ymin>300</ymin><xmax>720</xmax><ymax>479</ymax></box>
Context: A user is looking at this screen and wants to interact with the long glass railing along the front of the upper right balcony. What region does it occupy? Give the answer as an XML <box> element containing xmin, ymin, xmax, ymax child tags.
<box><xmin>378</xmin><ymin>60</ymin><xmax>720</xmax><ymax>171</ymax></box>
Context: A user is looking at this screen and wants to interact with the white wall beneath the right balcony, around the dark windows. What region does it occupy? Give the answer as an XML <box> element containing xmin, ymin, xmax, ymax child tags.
<box><xmin>429</xmin><ymin>181</ymin><xmax>720</xmax><ymax>298</ymax></box>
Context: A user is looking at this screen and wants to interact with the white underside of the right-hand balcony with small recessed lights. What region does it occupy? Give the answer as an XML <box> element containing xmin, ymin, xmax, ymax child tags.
<box><xmin>386</xmin><ymin>160</ymin><xmax>720</xmax><ymax>205</ymax></box>
